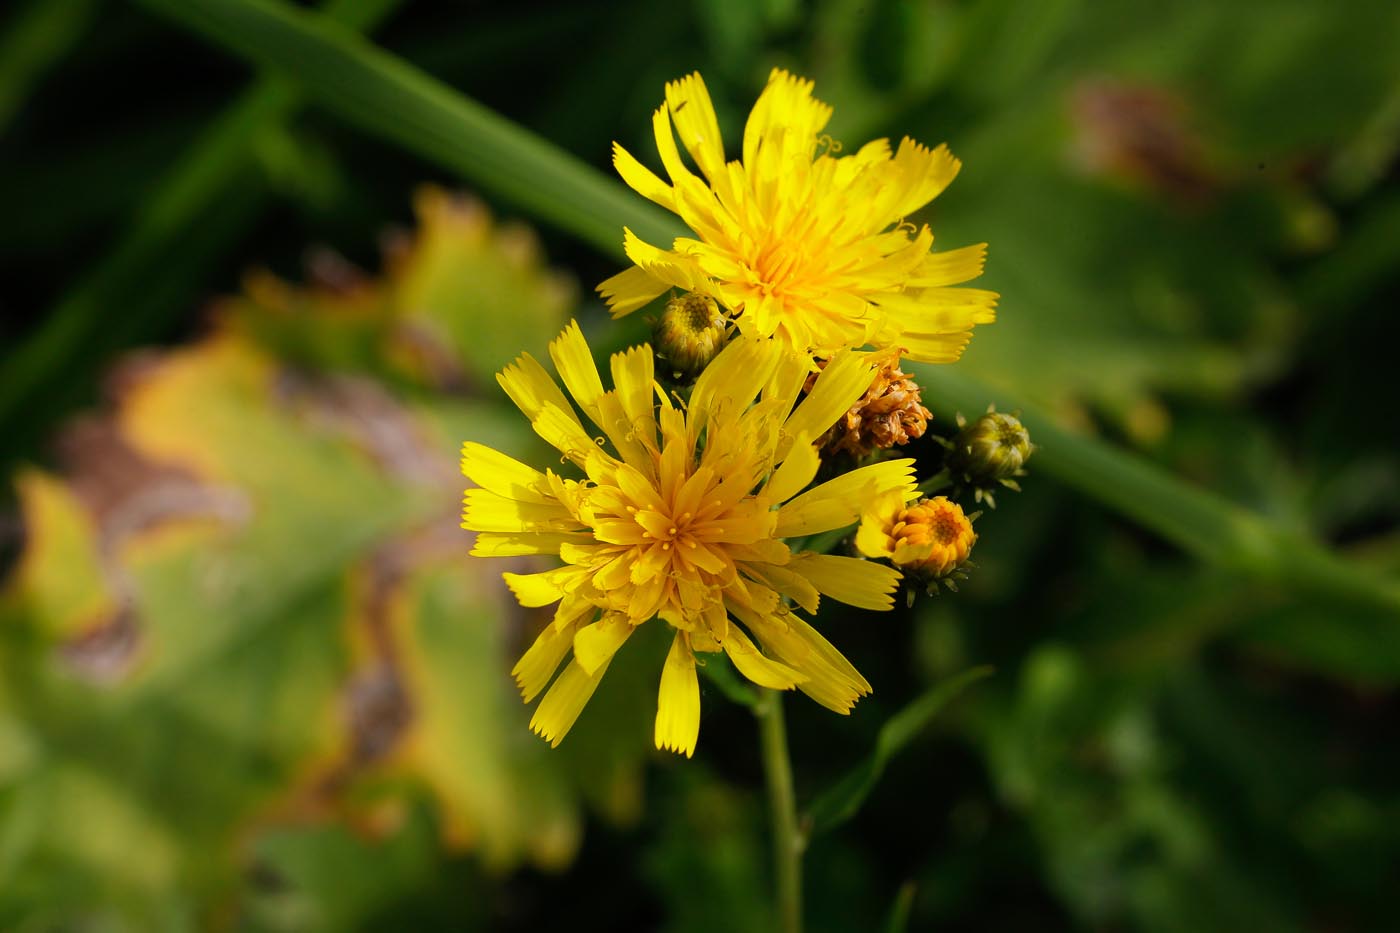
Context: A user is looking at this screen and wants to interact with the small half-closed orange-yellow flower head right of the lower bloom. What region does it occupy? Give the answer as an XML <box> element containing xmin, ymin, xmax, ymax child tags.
<box><xmin>855</xmin><ymin>490</ymin><xmax>977</xmax><ymax>577</ymax></box>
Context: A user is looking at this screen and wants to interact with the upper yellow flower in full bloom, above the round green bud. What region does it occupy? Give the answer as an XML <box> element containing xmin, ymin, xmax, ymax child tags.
<box><xmin>598</xmin><ymin>70</ymin><xmax>997</xmax><ymax>363</ymax></box>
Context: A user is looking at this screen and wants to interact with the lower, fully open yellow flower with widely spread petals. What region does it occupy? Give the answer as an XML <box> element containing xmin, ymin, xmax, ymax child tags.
<box><xmin>462</xmin><ymin>324</ymin><xmax>913</xmax><ymax>755</ymax></box>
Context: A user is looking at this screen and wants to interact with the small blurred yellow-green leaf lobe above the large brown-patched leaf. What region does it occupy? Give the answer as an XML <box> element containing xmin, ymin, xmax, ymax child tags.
<box><xmin>221</xmin><ymin>185</ymin><xmax>577</xmax><ymax>391</ymax></box>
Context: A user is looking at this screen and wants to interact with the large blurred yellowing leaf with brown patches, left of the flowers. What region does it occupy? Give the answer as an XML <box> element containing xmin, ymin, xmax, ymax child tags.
<box><xmin>0</xmin><ymin>190</ymin><xmax>596</xmax><ymax>929</ymax></box>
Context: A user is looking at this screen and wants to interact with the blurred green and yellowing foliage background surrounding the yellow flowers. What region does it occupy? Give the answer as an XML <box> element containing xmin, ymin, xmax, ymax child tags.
<box><xmin>0</xmin><ymin>0</ymin><xmax>1400</xmax><ymax>930</ymax></box>
